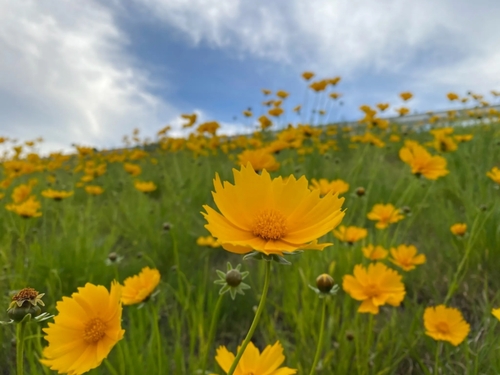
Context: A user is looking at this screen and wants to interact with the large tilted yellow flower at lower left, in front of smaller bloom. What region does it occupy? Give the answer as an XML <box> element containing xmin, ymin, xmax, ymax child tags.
<box><xmin>40</xmin><ymin>281</ymin><xmax>125</xmax><ymax>375</ymax></box>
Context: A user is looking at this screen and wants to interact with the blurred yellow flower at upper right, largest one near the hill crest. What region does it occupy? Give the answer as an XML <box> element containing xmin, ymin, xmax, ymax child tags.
<box><xmin>399</xmin><ymin>141</ymin><xmax>449</xmax><ymax>180</ymax></box>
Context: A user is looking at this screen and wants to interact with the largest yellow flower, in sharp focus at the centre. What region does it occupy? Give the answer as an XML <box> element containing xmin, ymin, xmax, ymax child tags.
<box><xmin>203</xmin><ymin>164</ymin><xmax>344</xmax><ymax>255</ymax></box>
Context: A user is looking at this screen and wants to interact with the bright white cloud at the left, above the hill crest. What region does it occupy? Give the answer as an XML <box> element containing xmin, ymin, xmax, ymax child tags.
<box><xmin>0</xmin><ymin>0</ymin><xmax>174</xmax><ymax>151</ymax></box>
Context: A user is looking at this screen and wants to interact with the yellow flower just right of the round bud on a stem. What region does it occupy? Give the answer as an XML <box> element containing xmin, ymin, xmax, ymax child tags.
<box><xmin>342</xmin><ymin>263</ymin><xmax>406</xmax><ymax>314</ymax></box>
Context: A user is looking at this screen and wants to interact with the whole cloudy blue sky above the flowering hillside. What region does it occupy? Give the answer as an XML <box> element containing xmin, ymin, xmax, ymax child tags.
<box><xmin>0</xmin><ymin>0</ymin><xmax>500</xmax><ymax>152</ymax></box>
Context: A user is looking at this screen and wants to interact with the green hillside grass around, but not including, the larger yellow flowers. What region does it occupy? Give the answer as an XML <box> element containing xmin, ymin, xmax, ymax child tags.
<box><xmin>0</xmin><ymin>107</ymin><xmax>500</xmax><ymax>375</ymax></box>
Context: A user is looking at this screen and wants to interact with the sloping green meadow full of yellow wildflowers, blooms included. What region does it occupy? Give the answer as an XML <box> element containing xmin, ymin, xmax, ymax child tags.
<box><xmin>0</xmin><ymin>72</ymin><xmax>500</xmax><ymax>375</ymax></box>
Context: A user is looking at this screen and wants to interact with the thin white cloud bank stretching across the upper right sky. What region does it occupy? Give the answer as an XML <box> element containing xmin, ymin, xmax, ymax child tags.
<box><xmin>136</xmin><ymin>0</ymin><xmax>500</xmax><ymax>88</ymax></box>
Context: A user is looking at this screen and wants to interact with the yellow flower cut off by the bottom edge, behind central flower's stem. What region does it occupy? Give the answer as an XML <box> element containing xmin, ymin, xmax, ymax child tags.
<box><xmin>215</xmin><ymin>341</ymin><xmax>297</xmax><ymax>375</ymax></box>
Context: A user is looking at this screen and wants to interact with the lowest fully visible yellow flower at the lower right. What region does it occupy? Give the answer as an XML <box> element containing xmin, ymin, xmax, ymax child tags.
<box><xmin>424</xmin><ymin>305</ymin><xmax>470</xmax><ymax>346</ymax></box>
